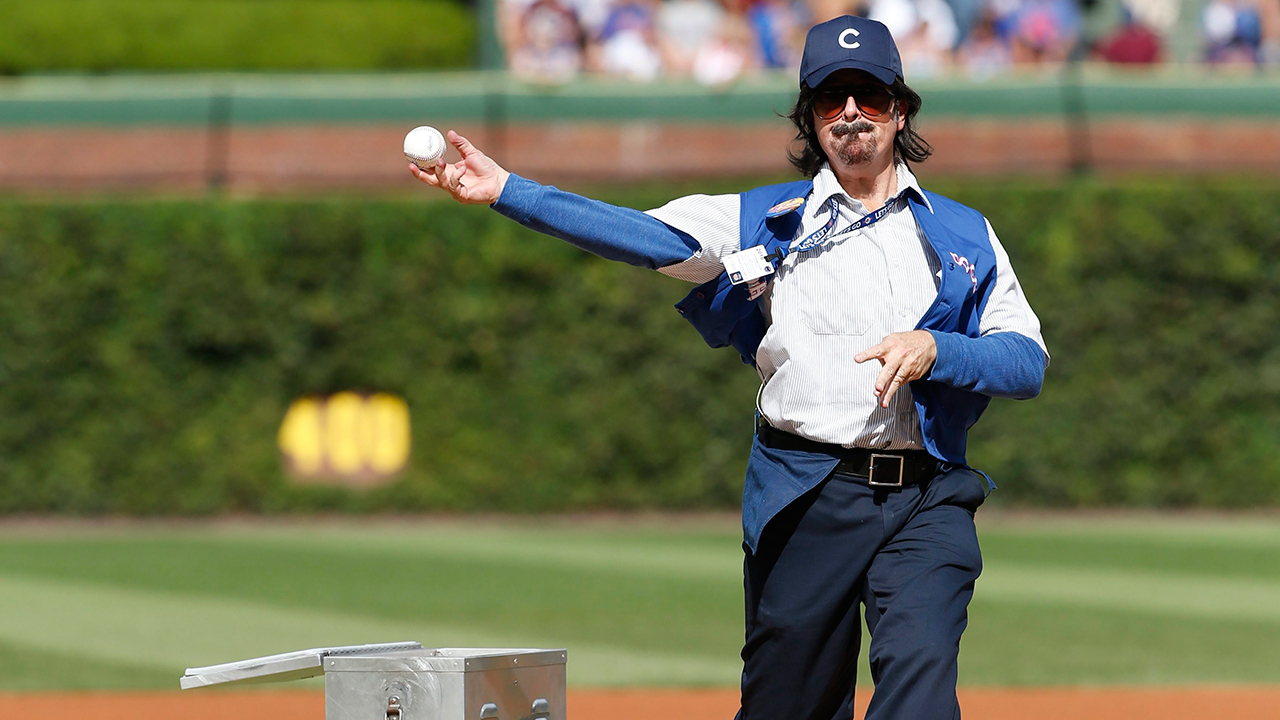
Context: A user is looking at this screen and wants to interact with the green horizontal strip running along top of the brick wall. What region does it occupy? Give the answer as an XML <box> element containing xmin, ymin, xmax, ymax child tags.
<box><xmin>0</xmin><ymin>68</ymin><xmax>1280</xmax><ymax>127</ymax></box>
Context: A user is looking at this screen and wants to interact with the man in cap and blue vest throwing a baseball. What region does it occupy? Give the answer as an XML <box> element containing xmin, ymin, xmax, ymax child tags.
<box><xmin>411</xmin><ymin>17</ymin><xmax>1048</xmax><ymax>720</ymax></box>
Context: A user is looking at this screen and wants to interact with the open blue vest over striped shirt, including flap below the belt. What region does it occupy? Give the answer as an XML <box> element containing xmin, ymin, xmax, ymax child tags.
<box><xmin>676</xmin><ymin>181</ymin><xmax>996</xmax><ymax>550</ymax></box>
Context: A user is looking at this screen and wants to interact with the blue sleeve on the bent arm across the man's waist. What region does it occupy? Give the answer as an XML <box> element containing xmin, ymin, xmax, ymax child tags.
<box><xmin>925</xmin><ymin>331</ymin><xmax>1044</xmax><ymax>400</ymax></box>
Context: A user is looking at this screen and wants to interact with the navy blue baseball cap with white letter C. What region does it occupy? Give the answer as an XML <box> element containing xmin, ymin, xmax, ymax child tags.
<box><xmin>800</xmin><ymin>15</ymin><xmax>902</xmax><ymax>87</ymax></box>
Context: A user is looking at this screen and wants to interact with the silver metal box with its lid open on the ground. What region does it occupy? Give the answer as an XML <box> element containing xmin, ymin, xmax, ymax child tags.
<box><xmin>182</xmin><ymin>643</ymin><xmax>568</xmax><ymax>720</ymax></box>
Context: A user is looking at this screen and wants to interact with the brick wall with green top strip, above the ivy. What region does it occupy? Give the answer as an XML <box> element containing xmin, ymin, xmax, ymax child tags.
<box><xmin>0</xmin><ymin>68</ymin><xmax>1280</xmax><ymax>191</ymax></box>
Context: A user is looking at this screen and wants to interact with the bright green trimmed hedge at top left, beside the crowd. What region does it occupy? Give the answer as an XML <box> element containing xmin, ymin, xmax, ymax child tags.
<box><xmin>0</xmin><ymin>0</ymin><xmax>476</xmax><ymax>74</ymax></box>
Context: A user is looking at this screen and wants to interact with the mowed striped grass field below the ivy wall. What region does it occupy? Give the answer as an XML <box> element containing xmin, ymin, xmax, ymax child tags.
<box><xmin>0</xmin><ymin>512</ymin><xmax>1280</xmax><ymax>691</ymax></box>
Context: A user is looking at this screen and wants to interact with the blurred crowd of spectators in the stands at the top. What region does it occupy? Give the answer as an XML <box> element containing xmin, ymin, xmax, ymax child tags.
<box><xmin>498</xmin><ymin>0</ymin><xmax>1280</xmax><ymax>86</ymax></box>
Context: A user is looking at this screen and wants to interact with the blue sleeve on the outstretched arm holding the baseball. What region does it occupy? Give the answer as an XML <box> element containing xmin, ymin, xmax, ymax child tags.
<box><xmin>493</xmin><ymin>173</ymin><xmax>701</xmax><ymax>269</ymax></box>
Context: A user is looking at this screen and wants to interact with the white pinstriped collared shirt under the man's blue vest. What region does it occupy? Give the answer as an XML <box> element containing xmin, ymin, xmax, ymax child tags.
<box><xmin>648</xmin><ymin>163</ymin><xmax>1048</xmax><ymax>450</ymax></box>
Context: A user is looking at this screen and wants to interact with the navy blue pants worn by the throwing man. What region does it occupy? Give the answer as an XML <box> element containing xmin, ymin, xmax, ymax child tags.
<box><xmin>737</xmin><ymin>466</ymin><xmax>986</xmax><ymax>720</ymax></box>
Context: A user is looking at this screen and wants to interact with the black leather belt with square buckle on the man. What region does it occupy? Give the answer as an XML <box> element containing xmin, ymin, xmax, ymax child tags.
<box><xmin>755</xmin><ymin>420</ymin><xmax>938</xmax><ymax>488</ymax></box>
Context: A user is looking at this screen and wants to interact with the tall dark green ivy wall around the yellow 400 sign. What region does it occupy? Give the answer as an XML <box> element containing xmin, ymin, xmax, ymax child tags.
<box><xmin>0</xmin><ymin>181</ymin><xmax>1280</xmax><ymax>515</ymax></box>
